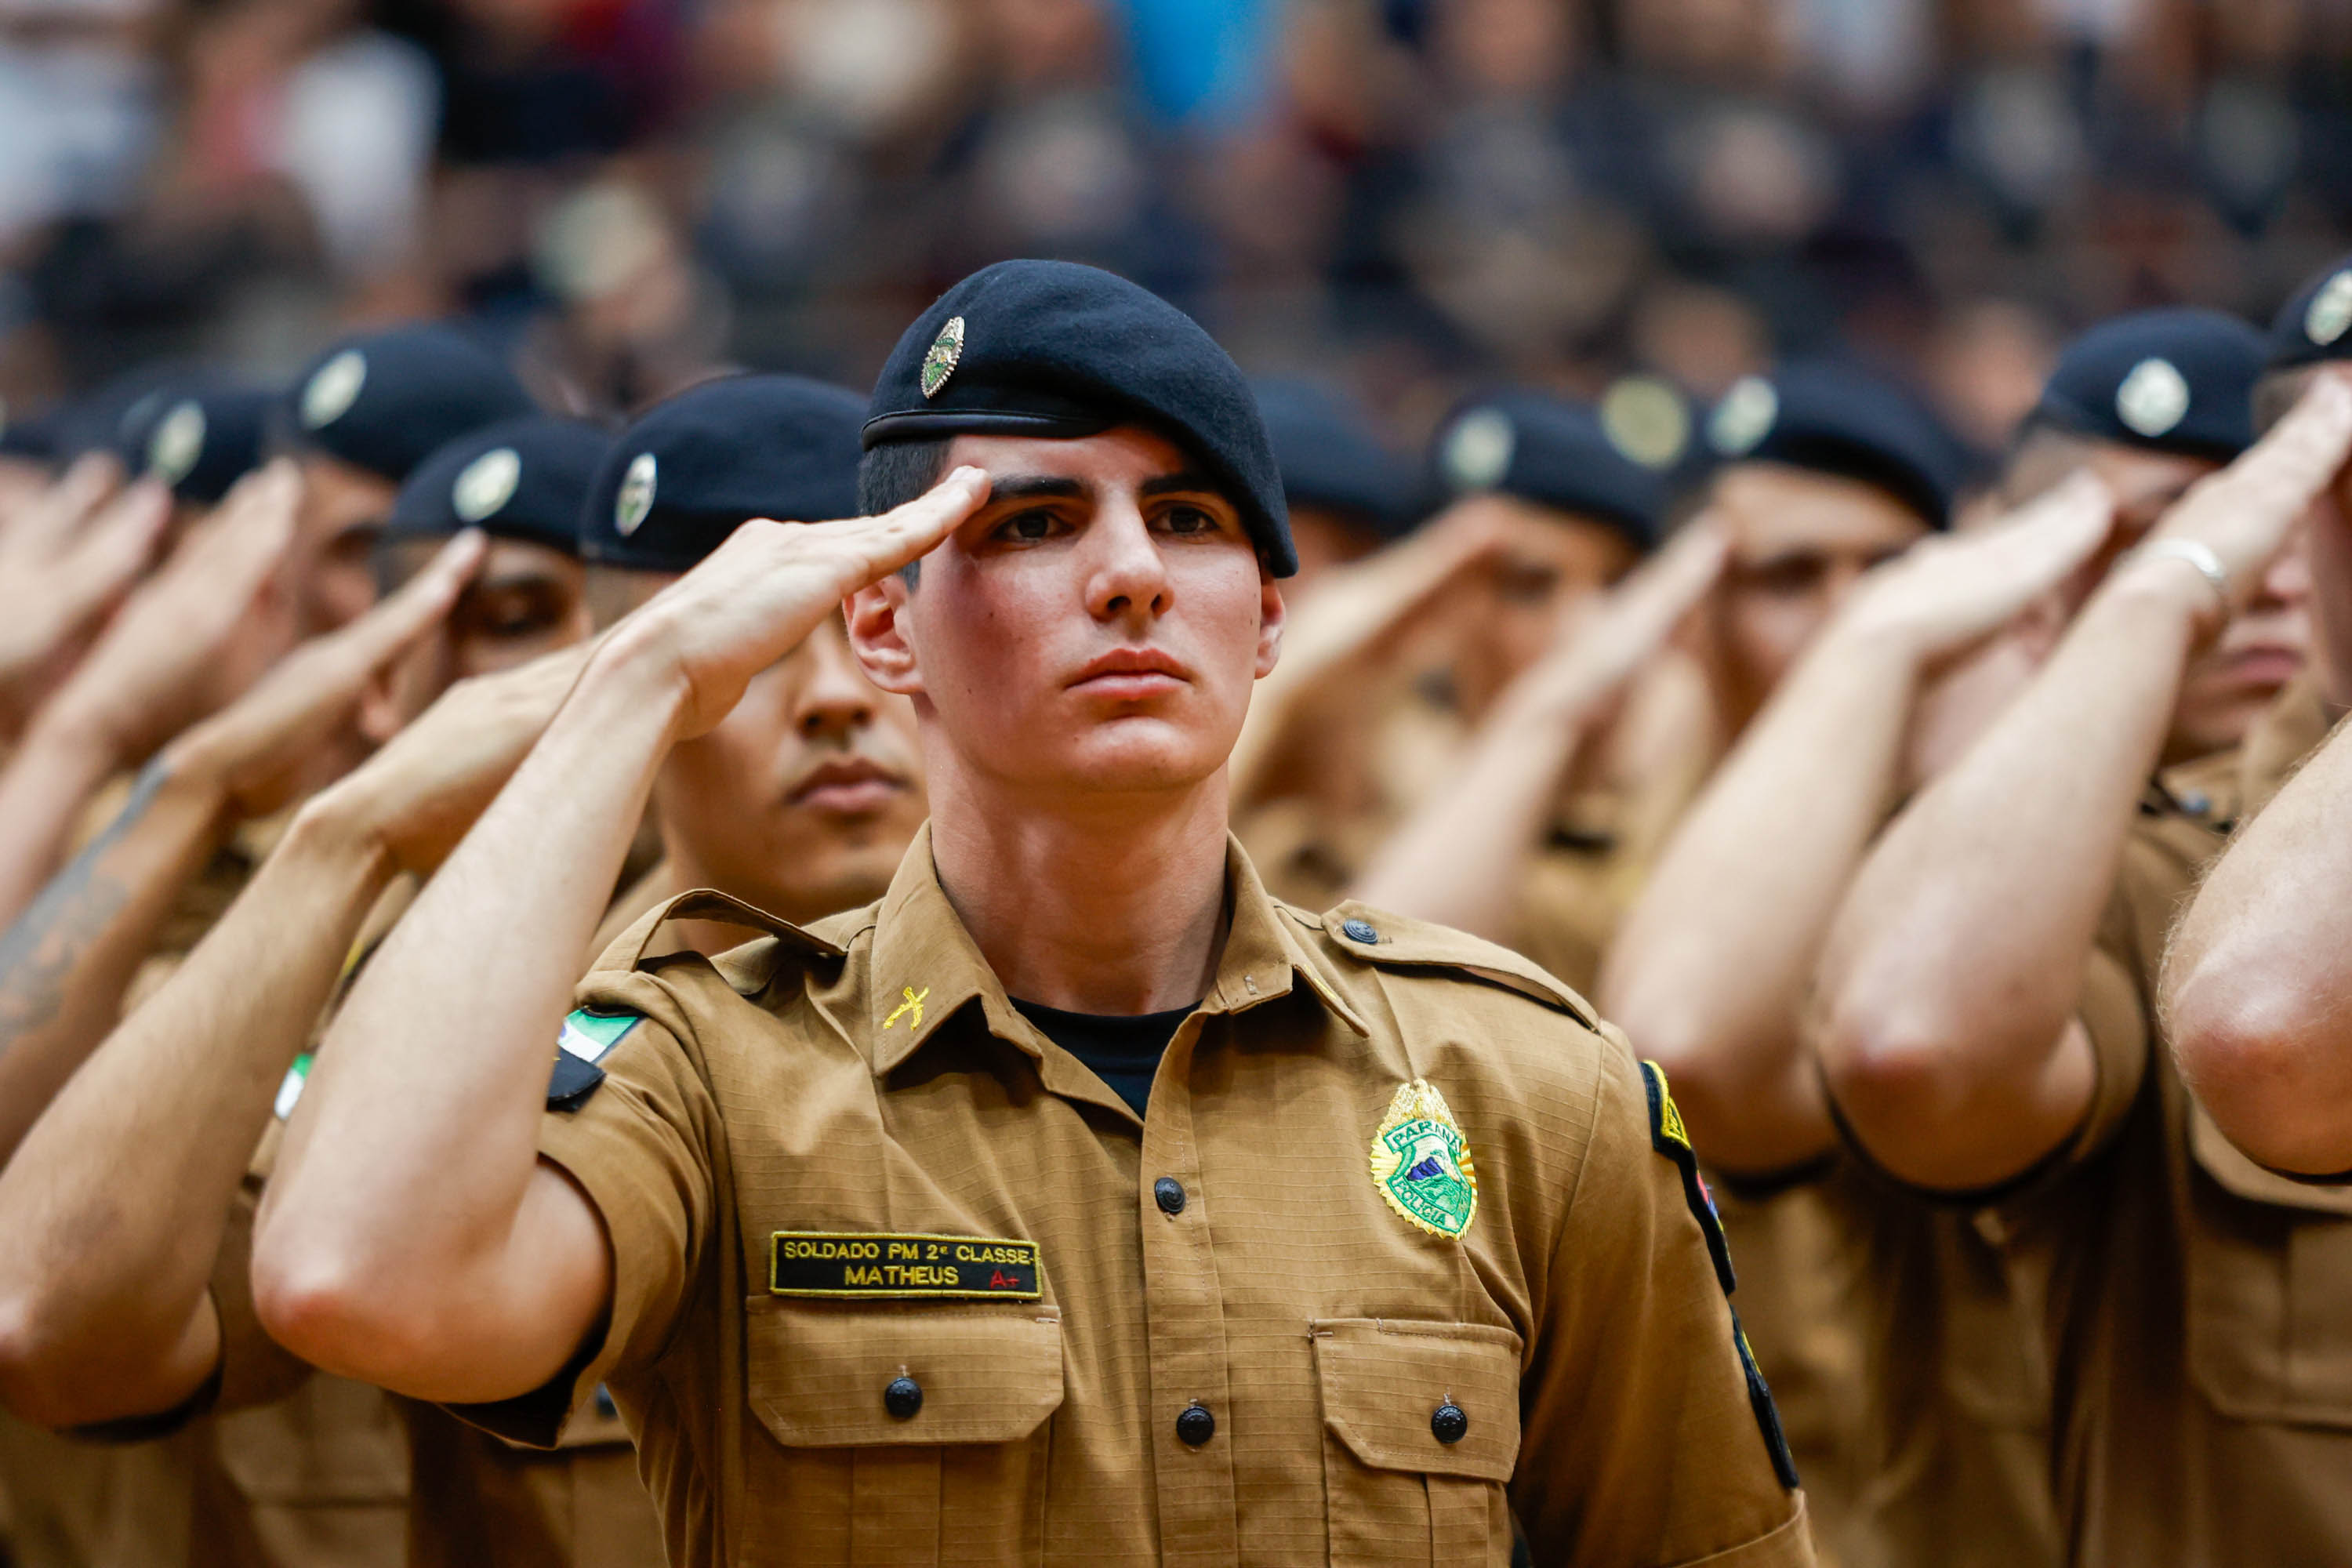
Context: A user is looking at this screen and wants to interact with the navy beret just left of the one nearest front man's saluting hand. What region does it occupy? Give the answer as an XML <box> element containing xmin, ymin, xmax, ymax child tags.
<box><xmin>386</xmin><ymin>414</ymin><xmax>612</xmax><ymax>555</ymax></box>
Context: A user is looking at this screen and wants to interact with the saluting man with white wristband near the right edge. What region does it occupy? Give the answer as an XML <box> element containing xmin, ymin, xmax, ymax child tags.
<box><xmin>1818</xmin><ymin>263</ymin><xmax>2352</xmax><ymax>1566</ymax></box>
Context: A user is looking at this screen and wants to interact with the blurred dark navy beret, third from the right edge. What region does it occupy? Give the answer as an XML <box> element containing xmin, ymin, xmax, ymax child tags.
<box><xmin>1708</xmin><ymin>360</ymin><xmax>1969</xmax><ymax>529</ymax></box>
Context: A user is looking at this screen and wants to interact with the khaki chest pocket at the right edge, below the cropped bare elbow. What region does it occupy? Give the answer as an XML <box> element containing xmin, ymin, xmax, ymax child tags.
<box><xmin>2187</xmin><ymin>1102</ymin><xmax>2352</xmax><ymax>1429</ymax></box>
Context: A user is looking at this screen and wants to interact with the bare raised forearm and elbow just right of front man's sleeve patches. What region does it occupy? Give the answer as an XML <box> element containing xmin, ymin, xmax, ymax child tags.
<box><xmin>1599</xmin><ymin>628</ymin><xmax>1917</xmax><ymax>1173</ymax></box>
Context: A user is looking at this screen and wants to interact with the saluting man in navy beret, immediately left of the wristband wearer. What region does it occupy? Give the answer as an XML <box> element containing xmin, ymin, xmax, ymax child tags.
<box><xmin>1602</xmin><ymin>310</ymin><xmax>2291</xmax><ymax>1566</ymax></box>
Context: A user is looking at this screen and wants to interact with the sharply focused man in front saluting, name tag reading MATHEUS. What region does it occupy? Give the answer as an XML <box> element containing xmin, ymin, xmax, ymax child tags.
<box><xmin>254</xmin><ymin>263</ymin><xmax>1811</xmax><ymax>1563</ymax></box>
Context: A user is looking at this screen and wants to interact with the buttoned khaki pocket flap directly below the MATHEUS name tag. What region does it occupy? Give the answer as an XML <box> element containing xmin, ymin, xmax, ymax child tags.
<box><xmin>743</xmin><ymin>1295</ymin><xmax>1063</xmax><ymax>1448</ymax></box>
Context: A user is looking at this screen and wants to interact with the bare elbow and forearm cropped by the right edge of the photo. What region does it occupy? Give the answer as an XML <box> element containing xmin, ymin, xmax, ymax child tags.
<box><xmin>2164</xmin><ymin>727</ymin><xmax>2352</xmax><ymax>1175</ymax></box>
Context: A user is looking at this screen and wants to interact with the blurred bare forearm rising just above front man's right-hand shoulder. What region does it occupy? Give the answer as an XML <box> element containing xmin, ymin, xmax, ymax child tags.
<box><xmin>1355</xmin><ymin>682</ymin><xmax>1592</xmax><ymax>940</ymax></box>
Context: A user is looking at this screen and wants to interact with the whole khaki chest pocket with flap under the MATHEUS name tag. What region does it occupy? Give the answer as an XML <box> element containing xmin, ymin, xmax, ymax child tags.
<box><xmin>736</xmin><ymin>1295</ymin><xmax>1063</xmax><ymax>1568</ymax></box>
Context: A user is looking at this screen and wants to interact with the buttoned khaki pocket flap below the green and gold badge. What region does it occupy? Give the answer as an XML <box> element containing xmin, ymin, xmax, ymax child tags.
<box><xmin>1308</xmin><ymin>1316</ymin><xmax>1519</xmax><ymax>1481</ymax></box>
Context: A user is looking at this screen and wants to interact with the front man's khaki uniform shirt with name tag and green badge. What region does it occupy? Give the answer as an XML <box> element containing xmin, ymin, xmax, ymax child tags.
<box><xmin>466</xmin><ymin>829</ymin><xmax>1811</xmax><ymax>1568</ymax></box>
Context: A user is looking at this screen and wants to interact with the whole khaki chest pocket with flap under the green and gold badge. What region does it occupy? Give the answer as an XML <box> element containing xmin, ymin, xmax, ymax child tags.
<box><xmin>1308</xmin><ymin>1319</ymin><xmax>1519</xmax><ymax>1568</ymax></box>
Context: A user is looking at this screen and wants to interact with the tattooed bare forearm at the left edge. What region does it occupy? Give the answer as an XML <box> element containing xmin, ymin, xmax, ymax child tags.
<box><xmin>0</xmin><ymin>762</ymin><xmax>226</xmax><ymax>1159</ymax></box>
